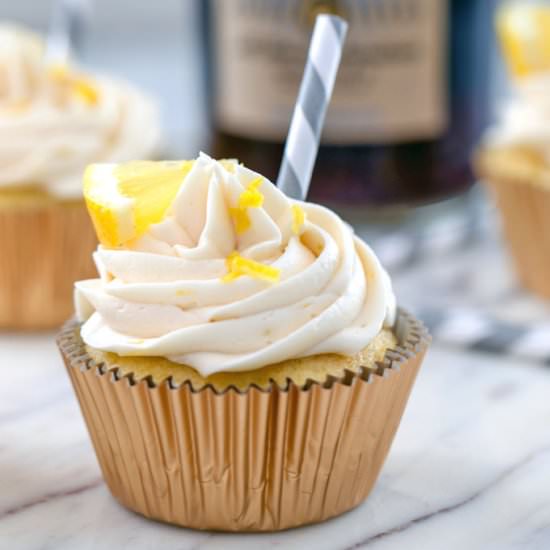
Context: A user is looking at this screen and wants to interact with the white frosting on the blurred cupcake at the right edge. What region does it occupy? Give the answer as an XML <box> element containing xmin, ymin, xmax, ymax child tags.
<box><xmin>486</xmin><ymin>73</ymin><xmax>550</xmax><ymax>160</ymax></box>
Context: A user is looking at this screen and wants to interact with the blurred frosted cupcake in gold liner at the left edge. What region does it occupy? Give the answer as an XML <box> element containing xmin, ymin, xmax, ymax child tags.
<box><xmin>0</xmin><ymin>25</ymin><xmax>159</xmax><ymax>329</ymax></box>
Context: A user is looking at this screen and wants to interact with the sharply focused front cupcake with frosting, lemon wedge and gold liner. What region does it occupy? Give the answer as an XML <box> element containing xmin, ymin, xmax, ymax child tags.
<box><xmin>58</xmin><ymin>155</ymin><xmax>428</xmax><ymax>531</ymax></box>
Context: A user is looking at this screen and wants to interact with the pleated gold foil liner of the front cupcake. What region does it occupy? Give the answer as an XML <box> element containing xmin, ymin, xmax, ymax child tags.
<box><xmin>58</xmin><ymin>310</ymin><xmax>429</xmax><ymax>531</ymax></box>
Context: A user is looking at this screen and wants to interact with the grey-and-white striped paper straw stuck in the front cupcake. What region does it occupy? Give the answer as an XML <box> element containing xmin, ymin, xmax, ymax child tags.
<box><xmin>277</xmin><ymin>15</ymin><xmax>348</xmax><ymax>200</ymax></box>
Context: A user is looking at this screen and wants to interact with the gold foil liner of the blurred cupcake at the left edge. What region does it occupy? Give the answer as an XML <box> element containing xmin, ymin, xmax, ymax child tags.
<box><xmin>0</xmin><ymin>201</ymin><xmax>97</xmax><ymax>329</ymax></box>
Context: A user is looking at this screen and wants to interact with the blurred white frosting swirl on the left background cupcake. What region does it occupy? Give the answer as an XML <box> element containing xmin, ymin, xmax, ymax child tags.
<box><xmin>0</xmin><ymin>26</ymin><xmax>160</xmax><ymax>197</ymax></box>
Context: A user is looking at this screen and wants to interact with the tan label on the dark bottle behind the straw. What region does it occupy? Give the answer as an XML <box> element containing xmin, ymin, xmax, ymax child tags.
<box><xmin>212</xmin><ymin>0</ymin><xmax>448</xmax><ymax>144</ymax></box>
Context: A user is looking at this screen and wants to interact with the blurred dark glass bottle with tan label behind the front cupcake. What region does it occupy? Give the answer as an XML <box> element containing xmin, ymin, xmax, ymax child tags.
<box><xmin>206</xmin><ymin>0</ymin><xmax>493</xmax><ymax>213</ymax></box>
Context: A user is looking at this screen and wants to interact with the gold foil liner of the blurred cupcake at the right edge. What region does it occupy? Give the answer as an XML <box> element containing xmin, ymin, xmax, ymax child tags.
<box><xmin>477</xmin><ymin>152</ymin><xmax>550</xmax><ymax>299</ymax></box>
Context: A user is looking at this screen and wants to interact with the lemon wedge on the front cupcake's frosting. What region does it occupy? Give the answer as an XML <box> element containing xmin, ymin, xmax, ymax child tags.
<box><xmin>84</xmin><ymin>161</ymin><xmax>193</xmax><ymax>248</ymax></box>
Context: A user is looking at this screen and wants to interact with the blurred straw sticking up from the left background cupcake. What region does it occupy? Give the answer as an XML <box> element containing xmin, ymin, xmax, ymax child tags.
<box><xmin>46</xmin><ymin>0</ymin><xmax>90</xmax><ymax>64</ymax></box>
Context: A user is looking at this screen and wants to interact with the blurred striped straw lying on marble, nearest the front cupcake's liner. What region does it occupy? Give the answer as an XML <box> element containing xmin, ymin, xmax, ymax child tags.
<box><xmin>418</xmin><ymin>309</ymin><xmax>550</xmax><ymax>365</ymax></box>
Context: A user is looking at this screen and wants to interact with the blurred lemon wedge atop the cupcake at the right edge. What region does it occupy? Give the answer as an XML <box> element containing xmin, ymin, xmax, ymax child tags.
<box><xmin>496</xmin><ymin>2</ymin><xmax>550</xmax><ymax>78</ymax></box>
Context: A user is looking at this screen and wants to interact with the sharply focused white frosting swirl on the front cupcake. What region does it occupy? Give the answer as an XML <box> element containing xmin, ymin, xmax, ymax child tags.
<box><xmin>76</xmin><ymin>155</ymin><xmax>395</xmax><ymax>376</ymax></box>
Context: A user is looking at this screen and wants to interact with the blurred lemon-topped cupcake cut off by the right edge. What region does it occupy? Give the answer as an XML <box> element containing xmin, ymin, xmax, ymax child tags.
<box><xmin>475</xmin><ymin>1</ymin><xmax>550</xmax><ymax>299</ymax></box>
